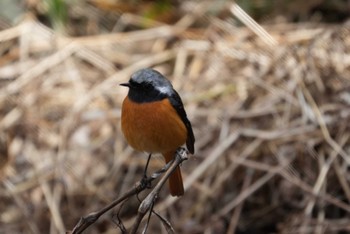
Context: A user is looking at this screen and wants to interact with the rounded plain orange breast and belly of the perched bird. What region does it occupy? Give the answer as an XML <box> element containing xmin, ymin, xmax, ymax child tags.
<box><xmin>121</xmin><ymin>97</ymin><xmax>187</xmax><ymax>153</ymax></box>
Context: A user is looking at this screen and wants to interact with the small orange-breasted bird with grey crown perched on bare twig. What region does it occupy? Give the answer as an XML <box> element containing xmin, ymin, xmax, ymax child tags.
<box><xmin>120</xmin><ymin>68</ymin><xmax>195</xmax><ymax>196</ymax></box>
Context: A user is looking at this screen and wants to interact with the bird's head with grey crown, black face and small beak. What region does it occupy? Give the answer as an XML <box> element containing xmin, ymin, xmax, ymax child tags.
<box><xmin>121</xmin><ymin>69</ymin><xmax>173</xmax><ymax>103</ymax></box>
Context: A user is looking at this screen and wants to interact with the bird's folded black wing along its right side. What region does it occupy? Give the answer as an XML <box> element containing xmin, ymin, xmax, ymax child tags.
<box><xmin>169</xmin><ymin>90</ymin><xmax>195</xmax><ymax>154</ymax></box>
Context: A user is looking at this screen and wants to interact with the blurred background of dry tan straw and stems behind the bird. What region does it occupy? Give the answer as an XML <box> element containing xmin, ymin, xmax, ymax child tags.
<box><xmin>0</xmin><ymin>0</ymin><xmax>350</xmax><ymax>234</ymax></box>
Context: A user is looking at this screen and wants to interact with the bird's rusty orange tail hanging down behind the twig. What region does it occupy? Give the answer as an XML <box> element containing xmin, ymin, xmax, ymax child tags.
<box><xmin>163</xmin><ymin>152</ymin><xmax>184</xmax><ymax>196</ymax></box>
